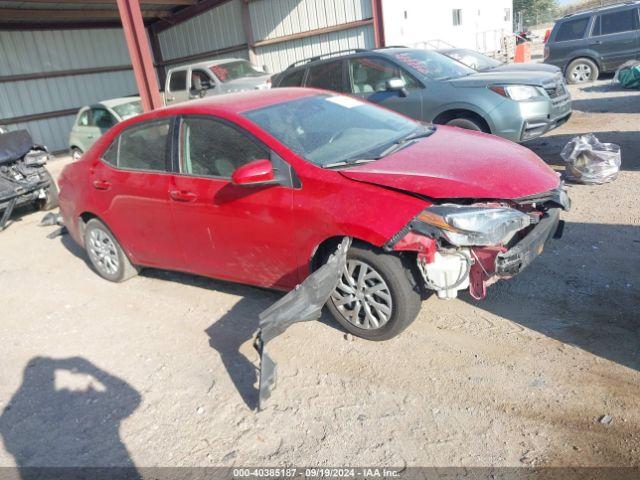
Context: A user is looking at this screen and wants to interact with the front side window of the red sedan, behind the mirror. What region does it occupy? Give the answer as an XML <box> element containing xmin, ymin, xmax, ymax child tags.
<box><xmin>180</xmin><ymin>117</ymin><xmax>269</xmax><ymax>178</ymax></box>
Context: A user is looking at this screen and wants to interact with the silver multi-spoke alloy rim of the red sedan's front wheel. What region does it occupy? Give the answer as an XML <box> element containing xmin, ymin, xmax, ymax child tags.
<box><xmin>331</xmin><ymin>259</ymin><xmax>393</xmax><ymax>330</ymax></box>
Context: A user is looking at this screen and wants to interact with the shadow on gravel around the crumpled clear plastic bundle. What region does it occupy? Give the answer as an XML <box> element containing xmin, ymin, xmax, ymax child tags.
<box><xmin>523</xmin><ymin>132</ymin><xmax>640</xmax><ymax>171</ymax></box>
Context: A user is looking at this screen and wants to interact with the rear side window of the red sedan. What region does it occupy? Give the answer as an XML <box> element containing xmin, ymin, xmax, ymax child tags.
<box><xmin>111</xmin><ymin>120</ymin><xmax>170</xmax><ymax>172</ymax></box>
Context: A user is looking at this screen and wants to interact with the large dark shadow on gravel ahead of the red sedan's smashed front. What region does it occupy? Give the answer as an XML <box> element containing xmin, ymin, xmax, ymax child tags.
<box><xmin>460</xmin><ymin>223</ymin><xmax>640</xmax><ymax>371</ymax></box>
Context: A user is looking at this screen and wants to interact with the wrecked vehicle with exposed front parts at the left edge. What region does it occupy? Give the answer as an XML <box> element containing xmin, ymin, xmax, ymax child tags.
<box><xmin>0</xmin><ymin>130</ymin><xmax>58</xmax><ymax>231</ymax></box>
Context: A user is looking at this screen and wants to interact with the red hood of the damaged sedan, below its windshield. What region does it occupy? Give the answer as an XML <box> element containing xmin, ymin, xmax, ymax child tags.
<box><xmin>340</xmin><ymin>126</ymin><xmax>560</xmax><ymax>200</ymax></box>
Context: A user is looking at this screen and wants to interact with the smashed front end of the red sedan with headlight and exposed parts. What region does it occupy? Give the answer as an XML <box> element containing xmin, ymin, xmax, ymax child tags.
<box><xmin>385</xmin><ymin>184</ymin><xmax>571</xmax><ymax>300</ymax></box>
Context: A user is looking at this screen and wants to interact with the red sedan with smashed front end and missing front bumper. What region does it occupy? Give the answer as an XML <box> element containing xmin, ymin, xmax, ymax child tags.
<box><xmin>60</xmin><ymin>88</ymin><xmax>569</xmax><ymax>340</ymax></box>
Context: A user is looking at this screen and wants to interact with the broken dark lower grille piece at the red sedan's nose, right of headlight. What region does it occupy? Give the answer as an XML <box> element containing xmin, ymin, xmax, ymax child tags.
<box><xmin>495</xmin><ymin>208</ymin><xmax>563</xmax><ymax>277</ymax></box>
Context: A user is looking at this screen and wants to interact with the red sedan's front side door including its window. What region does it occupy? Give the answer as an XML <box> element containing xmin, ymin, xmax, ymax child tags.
<box><xmin>170</xmin><ymin>116</ymin><xmax>298</xmax><ymax>289</ymax></box>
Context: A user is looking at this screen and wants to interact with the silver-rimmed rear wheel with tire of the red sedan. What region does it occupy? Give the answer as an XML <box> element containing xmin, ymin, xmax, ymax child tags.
<box><xmin>84</xmin><ymin>218</ymin><xmax>139</xmax><ymax>283</ymax></box>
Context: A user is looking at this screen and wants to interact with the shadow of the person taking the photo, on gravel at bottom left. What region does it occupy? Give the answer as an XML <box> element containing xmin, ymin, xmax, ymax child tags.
<box><xmin>0</xmin><ymin>357</ymin><xmax>141</xmax><ymax>480</ymax></box>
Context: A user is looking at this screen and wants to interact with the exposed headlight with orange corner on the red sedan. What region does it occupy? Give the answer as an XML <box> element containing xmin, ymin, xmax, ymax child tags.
<box><xmin>415</xmin><ymin>205</ymin><xmax>531</xmax><ymax>247</ymax></box>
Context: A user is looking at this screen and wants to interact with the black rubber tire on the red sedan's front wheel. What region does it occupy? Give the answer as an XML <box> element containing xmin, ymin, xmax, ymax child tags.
<box><xmin>327</xmin><ymin>245</ymin><xmax>422</xmax><ymax>341</ymax></box>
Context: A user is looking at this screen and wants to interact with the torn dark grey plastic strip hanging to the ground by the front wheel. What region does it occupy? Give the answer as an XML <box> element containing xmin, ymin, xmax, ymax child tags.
<box><xmin>253</xmin><ymin>237</ymin><xmax>351</xmax><ymax>410</ymax></box>
